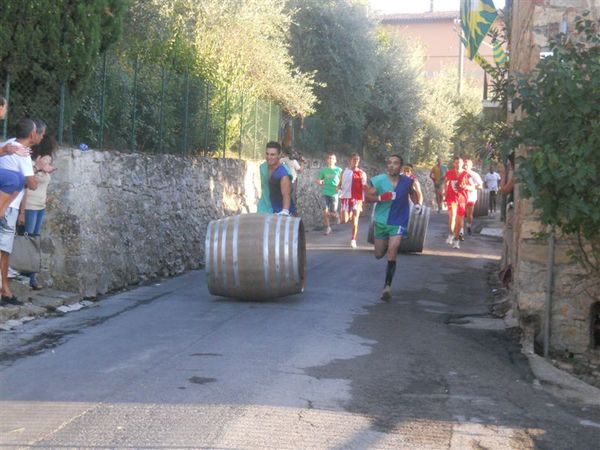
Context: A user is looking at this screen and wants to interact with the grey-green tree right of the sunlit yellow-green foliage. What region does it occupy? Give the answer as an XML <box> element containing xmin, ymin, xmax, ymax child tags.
<box><xmin>288</xmin><ymin>0</ymin><xmax>378</xmax><ymax>151</ymax></box>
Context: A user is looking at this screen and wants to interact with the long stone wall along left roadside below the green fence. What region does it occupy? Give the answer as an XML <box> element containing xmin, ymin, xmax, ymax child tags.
<box><xmin>40</xmin><ymin>149</ymin><xmax>430</xmax><ymax>297</ymax></box>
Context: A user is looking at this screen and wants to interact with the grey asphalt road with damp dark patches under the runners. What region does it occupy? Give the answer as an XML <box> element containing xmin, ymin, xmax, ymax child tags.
<box><xmin>0</xmin><ymin>214</ymin><xmax>600</xmax><ymax>449</ymax></box>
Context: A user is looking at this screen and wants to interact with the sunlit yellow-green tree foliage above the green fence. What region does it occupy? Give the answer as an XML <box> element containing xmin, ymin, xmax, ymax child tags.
<box><xmin>126</xmin><ymin>0</ymin><xmax>316</xmax><ymax>115</ymax></box>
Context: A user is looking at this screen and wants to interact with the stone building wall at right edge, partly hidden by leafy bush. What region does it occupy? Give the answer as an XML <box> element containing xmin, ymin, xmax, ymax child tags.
<box><xmin>503</xmin><ymin>0</ymin><xmax>600</xmax><ymax>353</ymax></box>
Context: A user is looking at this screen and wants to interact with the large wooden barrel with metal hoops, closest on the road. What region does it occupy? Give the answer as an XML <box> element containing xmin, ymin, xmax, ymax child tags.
<box><xmin>204</xmin><ymin>214</ymin><xmax>306</xmax><ymax>300</ymax></box>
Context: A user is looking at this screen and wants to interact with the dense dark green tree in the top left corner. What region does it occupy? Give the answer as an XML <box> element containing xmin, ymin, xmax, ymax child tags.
<box><xmin>0</xmin><ymin>0</ymin><xmax>128</xmax><ymax>128</ymax></box>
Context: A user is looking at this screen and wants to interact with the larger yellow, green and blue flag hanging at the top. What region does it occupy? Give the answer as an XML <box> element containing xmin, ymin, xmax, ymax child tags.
<box><xmin>460</xmin><ymin>0</ymin><xmax>498</xmax><ymax>59</ymax></box>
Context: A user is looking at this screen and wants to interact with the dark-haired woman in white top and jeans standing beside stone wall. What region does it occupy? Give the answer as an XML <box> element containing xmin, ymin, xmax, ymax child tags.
<box><xmin>19</xmin><ymin>135</ymin><xmax>57</xmax><ymax>290</ymax></box>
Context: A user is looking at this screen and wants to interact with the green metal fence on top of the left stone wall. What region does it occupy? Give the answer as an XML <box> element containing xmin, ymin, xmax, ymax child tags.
<box><xmin>0</xmin><ymin>52</ymin><xmax>281</xmax><ymax>159</ymax></box>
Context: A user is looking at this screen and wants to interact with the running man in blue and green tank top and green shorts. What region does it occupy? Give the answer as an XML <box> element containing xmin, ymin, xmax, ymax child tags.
<box><xmin>366</xmin><ymin>155</ymin><xmax>423</xmax><ymax>301</ymax></box>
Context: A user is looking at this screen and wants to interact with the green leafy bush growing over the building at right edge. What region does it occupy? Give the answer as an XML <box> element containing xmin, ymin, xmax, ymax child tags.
<box><xmin>514</xmin><ymin>16</ymin><xmax>600</xmax><ymax>279</ymax></box>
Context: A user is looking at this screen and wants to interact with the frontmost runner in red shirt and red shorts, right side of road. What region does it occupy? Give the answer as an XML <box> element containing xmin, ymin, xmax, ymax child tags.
<box><xmin>444</xmin><ymin>156</ymin><xmax>470</xmax><ymax>248</ymax></box>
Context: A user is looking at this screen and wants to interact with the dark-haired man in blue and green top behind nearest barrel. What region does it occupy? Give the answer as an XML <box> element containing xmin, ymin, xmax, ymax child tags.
<box><xmin>258</xmin><ymin>141</ymin><xmax>296</xmax><ymax>216</ymax></box>
